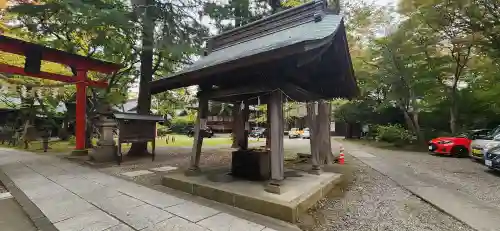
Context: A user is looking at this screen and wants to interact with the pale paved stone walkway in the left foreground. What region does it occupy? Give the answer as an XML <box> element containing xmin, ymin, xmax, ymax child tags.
<box><xmin>0</xmin><ymin>148</ymin><xmax>278</xmax><ymax>231</ymax></box>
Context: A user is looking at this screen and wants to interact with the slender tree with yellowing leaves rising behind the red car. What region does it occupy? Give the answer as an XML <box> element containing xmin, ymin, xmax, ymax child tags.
<box><xmin>401</xmin><ymin>0</ymin><xmax>477</xmax><ymax>134</ymax></box>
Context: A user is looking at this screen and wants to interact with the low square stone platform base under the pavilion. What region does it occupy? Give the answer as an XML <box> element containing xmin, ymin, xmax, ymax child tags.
<box><xmin>162</xmin><ymin>168</ymin><xmax>342</xmax><ymax>223</ymax></box>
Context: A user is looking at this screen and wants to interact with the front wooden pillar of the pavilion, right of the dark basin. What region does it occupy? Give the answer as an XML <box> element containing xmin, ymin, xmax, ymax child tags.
<box><xmin>266</xmin><ymin>91</ymin><xmax>285</xmax><ymax>194</ymax></box>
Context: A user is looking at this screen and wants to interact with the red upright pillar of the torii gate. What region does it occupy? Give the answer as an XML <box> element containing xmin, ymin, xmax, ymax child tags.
<box><xmin>75</xmin><ymin>70</ymin><xmax>87</xmax><ymax>153</ymax></box>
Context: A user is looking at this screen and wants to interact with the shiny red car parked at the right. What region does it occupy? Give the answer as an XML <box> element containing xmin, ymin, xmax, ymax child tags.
<box><xmin>429</xmin><ymin>129</ymin><xmax>489</xmax><ymax>157</ymax></box>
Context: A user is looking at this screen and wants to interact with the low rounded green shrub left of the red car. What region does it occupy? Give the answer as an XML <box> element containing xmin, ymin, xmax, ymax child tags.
<box><xmin>376</xmin><ymin>124</ymin><xmax>416</xmax><ymax>145</ymax></box>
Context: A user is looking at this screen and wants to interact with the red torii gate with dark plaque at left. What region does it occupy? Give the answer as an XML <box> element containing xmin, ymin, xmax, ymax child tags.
<box><xmin>0</xmin><ymin>35</ymin><xmax>122</xmax><ymax>153</ymax></box>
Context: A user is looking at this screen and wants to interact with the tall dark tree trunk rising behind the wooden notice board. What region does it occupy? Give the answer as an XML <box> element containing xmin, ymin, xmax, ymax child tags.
<box><xmin>129</xmin><ymin>0</ymin><xmax>154</xmax><ymax>156</ymax></box>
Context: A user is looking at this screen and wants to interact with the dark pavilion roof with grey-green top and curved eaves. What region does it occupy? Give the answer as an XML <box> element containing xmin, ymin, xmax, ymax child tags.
<box><xmin>151</xmin><ymin>0</ymin><xmax>357</xmax><ymax>101</ymax></box>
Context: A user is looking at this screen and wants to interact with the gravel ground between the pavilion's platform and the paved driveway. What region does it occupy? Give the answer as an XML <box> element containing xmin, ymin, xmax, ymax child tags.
<box><xmin>313</xmin><ymin>158</ymin><xmax>472</xmax><ymax>231</ymax></box>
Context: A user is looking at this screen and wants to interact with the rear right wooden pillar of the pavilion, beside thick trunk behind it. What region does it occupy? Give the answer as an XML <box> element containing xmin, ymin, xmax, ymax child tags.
<box><xmin>307</xmin><ymin>102</ymin><xmax>321</xmax><ymax>174</ymax></box>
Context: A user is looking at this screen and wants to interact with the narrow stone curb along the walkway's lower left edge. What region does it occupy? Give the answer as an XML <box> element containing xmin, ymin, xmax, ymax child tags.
<box><xmin>0</xmin><ymin>168</ymin><xmax>59</xmax><ymax>231</ymax></box>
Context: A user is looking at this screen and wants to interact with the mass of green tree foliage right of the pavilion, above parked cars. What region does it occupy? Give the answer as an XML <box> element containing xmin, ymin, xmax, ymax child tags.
<box><xmin>335</xmin><ymin>0</ymin><xmax>500</xmax><ymax>140</ymax></box>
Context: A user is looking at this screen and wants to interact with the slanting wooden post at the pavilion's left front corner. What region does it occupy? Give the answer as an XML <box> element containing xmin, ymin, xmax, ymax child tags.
<box><xmin>186</xmin><ymin>96</ymin><xmax>208</xmax><ymax>175</ymax></box>
